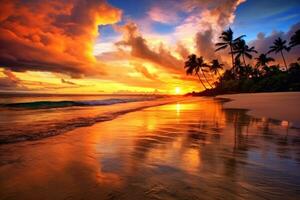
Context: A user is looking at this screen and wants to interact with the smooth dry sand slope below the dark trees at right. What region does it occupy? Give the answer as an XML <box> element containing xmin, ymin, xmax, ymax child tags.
<box><xmin>218</xmin><ymin>92</ymin><xmax>300</xmax><ymax>128</ymax></box>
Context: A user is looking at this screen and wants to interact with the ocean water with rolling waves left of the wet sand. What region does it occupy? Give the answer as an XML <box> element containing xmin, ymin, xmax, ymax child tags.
<box><xmin>0</xmin><ymin>94</ymin><xmax>174</xmax><ymax>144</ymax></box>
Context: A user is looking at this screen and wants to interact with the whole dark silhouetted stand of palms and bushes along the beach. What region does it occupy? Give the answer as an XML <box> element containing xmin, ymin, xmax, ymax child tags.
<box><xmin>184</xmin><ymin>28</ymin><xmax>300</xmax><ymax>95</ymax></box>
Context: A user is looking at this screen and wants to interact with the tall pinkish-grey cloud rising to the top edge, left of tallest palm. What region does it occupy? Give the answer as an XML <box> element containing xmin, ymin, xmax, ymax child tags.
<box><xmin>175</xmin><ymin>0</ymin><xmax>244</xmax><ymax>65</ymax></box>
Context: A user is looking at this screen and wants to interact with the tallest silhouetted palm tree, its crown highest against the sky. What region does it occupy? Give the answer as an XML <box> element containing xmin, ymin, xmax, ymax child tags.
<box><xmin>215</xmin><ymin>27</ymin><xmax>245</xmax><ymax>70</ymax></box>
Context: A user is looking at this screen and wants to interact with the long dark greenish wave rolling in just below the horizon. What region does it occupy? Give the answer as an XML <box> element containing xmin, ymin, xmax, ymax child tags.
<box><xmin>1</xmin><ymin>97</ymin><xmax>159</xmax><ymax>109</ymax></box>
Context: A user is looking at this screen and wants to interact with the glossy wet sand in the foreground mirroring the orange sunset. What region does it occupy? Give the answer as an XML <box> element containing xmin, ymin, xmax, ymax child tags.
<box><xmin>0</xmin><ymin>98</ymin><xmax>300</xmax><ymax>200</ymax></box>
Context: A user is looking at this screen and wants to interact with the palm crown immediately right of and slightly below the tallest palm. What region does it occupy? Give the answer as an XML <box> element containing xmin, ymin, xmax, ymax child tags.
<box><xmin>232</xmin><ymin>39</ymin><xmax>257</xmax><ymax>66</ymax></box>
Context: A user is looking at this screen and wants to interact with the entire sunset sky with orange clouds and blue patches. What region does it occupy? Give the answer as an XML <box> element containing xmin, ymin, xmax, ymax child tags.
<box><xmin>0</xmin><ymin>0</ymin><xmax>300</xmax><ymax>94</ymax></box>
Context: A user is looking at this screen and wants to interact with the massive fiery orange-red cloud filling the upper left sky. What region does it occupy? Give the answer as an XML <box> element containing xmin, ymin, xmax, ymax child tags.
<box><xmin>0</xmin><ymin>0</ymin><xmax>121</xmax><ymax>77</ymax></box>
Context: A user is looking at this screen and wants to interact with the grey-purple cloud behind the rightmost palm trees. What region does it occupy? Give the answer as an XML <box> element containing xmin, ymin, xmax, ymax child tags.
<box><xmin>250</xmin><ymin>23</ymin><xmax>300</xmax><ymax>64</ymax></box>
